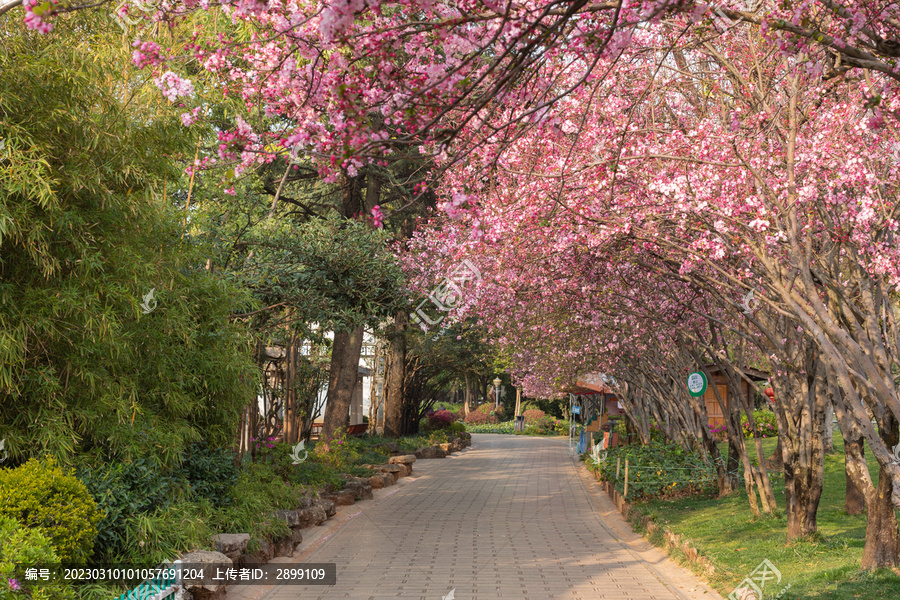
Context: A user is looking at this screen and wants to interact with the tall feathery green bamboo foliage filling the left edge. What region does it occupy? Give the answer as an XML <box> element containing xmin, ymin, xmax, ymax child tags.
<box><xmin>0</xmin><ymin>13</ymin><xmax>253</xmax><ymax>466</ymax></box>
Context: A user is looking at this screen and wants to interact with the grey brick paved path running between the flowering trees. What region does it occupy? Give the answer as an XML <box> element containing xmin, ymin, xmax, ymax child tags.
<box><xmin>265</xmin><ymin>435</ymin><xmax>710</xmax><ymax>600</ymax></box>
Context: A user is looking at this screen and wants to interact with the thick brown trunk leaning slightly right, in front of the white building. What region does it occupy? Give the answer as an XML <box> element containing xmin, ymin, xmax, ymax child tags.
<box><xmin>319</xmin><ymin>325</ymin><xmax>363</xmax><ymax>447</ymax></box>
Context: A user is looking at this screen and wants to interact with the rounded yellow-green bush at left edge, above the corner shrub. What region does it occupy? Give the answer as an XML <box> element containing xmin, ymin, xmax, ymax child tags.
<box><xmin>0</xmin><ymin>458</ymin><xmax>101</xmax><ymax>565</ymax></box>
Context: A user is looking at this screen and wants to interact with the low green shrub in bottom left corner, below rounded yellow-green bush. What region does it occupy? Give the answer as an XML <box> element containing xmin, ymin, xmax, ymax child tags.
<box><xmin>0</xmin><ymin>515</ymin><xmax>74</xmax><ymax>600</ymax></box>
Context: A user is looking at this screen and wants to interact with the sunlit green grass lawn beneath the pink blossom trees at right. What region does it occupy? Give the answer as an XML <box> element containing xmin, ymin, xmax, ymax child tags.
<box><xmin>634</xmin><ymin>431</ymin><xmax>900</xmax><ymax>600</ymax></box>
